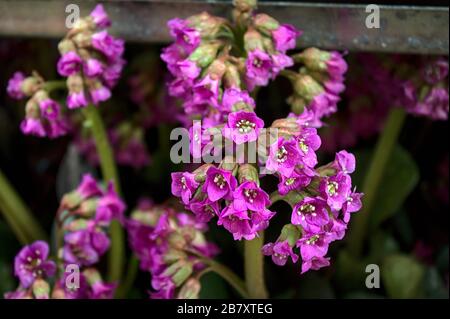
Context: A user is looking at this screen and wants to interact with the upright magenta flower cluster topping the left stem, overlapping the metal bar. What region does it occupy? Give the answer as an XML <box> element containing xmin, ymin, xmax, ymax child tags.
<box><xmin>57</xmin><ymin>5</ymin><xmax>125</xmax><ymax>109</ymax></box>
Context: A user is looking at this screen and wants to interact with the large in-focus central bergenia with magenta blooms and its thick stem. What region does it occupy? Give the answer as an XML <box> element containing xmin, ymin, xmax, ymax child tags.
<box><xmin>161</xmin><ymin>1</ymin><xmax>362</xmax><ymax>297</ymax></box>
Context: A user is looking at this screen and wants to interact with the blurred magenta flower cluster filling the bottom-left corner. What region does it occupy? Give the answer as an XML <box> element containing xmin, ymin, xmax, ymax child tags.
<box><xmin>5</xmin><ymin>175</ymin><xmax>125</xmax><ymax>299</ymax></box>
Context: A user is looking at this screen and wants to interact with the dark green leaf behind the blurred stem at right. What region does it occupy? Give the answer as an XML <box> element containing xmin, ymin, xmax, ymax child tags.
<box><xmin>353</xmin><ymin>145</ymin><xmax>419</xmax><ymax>230</ymax></box>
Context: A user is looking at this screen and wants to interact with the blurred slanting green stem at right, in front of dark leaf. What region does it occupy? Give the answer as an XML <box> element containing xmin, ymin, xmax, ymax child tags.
<box><xmin>348</xmin><ymin>107</ymin><xmax>406</xmax><ymax>257</ymax></box>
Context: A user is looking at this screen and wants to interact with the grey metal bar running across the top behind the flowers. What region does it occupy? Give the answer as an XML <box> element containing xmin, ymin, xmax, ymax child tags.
<box><xmin>0</xmin><ymin>0</ymin><xmax>449</xmax><ymax>54</ymax></box>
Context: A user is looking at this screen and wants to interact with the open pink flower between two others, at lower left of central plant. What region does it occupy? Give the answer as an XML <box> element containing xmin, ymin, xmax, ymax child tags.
<box><xmin>203</xmin><ymin>166</ymin><xmax>237</xmax><ymax>202</ymax></box>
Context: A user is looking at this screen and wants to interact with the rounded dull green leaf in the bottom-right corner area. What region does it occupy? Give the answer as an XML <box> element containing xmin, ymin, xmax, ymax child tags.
<box><xmin>381</xmin><ymin>254</ymin><xmax>425</xmax><ymax>299</ymax></box>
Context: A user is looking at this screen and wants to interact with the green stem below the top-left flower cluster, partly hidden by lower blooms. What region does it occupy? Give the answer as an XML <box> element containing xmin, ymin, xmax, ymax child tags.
<box><xmin>83</xmin><ymin>105</ymin><xmax>125</xmax><ymax>281</ymax></box>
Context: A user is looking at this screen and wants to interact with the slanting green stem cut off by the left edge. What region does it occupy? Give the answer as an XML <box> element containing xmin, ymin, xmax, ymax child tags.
<box><xmin>0</xmin><ymin>170</ymin><xmax>46</xmax><ymax>244</ymax></box>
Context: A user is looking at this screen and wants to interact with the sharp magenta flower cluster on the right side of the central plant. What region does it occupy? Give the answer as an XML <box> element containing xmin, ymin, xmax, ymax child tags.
<box><xmin>263</xmin><ymin>148</ymin><xmax>363</xmax><ymax>273</ymax></box>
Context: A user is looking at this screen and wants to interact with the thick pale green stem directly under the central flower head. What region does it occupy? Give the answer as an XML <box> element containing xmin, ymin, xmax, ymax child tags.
<box><xmin>244</xmin><ymin>232</ymin><xmax>268</xmax><ymax>299</ymax></box>
